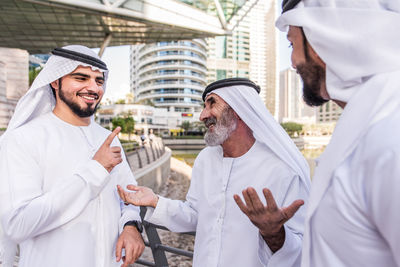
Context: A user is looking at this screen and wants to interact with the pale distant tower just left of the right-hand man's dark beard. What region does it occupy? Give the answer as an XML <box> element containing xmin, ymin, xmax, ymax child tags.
<box><xmin>278</xmin><ymin>68</ymin><xmax>315</xmax><ymax>123</ymax></box>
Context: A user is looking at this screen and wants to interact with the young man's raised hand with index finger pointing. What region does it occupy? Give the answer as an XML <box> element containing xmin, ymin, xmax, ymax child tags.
<box><xmin>93</xmin><ymin>127</ymin><xmax>122</xmax><ymax>172</ymax></box>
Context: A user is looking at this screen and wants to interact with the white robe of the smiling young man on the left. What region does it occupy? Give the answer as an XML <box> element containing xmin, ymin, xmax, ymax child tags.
<box><xmin>0</xmin><ymin>112</ymin><xmax>140</xmax><ymax>267</ymax></box>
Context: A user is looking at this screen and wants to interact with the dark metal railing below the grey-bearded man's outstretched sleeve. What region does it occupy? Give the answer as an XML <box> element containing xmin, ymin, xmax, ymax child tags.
<box><xmin>135</xmin><ymin>207</ymin><xmax>196</xmax><ymax>267</ymax></box>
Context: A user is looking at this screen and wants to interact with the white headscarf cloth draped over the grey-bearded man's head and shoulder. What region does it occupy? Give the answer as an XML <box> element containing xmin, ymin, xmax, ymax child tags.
<box><xmin>211</xmin><ymin>85</ymin><xmax>310</xmax><ymax>189</ymax></box>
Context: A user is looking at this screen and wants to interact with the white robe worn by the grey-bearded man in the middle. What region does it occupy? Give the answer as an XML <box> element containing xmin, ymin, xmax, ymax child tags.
<box><xmin>145</xmin><ymin>141</ymin><xmax>308</xmax><ymax>267</ymax></box>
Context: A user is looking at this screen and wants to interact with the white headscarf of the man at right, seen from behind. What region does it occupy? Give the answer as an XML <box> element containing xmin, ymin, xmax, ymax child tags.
<box><xmin>276</xmin><ymin>0</ymin><xmax>400</xmax><ymax>266</ymax></box>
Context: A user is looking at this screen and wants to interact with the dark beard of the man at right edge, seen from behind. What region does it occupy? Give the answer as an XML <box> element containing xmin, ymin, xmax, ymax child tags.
<box><xmin>296</xmin><ymin>56</ymin><xmax>329</xmax><ymax>106</ymax></box>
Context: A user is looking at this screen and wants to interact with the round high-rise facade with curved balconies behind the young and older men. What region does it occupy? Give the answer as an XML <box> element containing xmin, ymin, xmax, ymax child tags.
<box><xmin>131</xmin><ymin>39</ymin><xmax>207</xmax><ymax>114</ymax></box>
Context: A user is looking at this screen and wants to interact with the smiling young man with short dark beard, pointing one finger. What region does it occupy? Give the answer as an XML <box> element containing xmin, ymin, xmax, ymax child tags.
<box><xmin>0</xmin><ymin>45</ymin><xmax>144</xmax><ymax>267</ymax></box>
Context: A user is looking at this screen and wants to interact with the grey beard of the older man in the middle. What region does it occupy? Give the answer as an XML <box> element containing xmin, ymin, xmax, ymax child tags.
<box><xmin>204</xmin><ymin>106</ymin><xmax>237</xmax><ymax>146</ymax></box>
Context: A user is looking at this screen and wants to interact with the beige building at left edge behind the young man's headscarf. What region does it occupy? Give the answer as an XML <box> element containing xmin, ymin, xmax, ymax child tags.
<box><xmin>0</xmin><ymin>47</ymin><xmax>29</xmax><ymax>128</ymax></box>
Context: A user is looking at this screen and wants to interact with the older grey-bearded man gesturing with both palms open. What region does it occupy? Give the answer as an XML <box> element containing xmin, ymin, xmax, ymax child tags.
<box><xmin>115</xmin><ymin>78</ymin><xmax>309</xmax><ymax>267</ymax></box>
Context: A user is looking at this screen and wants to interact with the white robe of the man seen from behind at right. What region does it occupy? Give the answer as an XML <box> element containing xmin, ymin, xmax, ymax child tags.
<box><xmin>303</xmin><ymin>112</ymin><xmax>400</xmax><ymax>267</ymax></box>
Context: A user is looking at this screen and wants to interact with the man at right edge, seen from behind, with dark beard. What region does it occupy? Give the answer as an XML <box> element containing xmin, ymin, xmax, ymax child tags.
<box><xmin>276</xmin><ymin>0</ymin><xmax>400</xmax><ymax>267</ymax></box>
